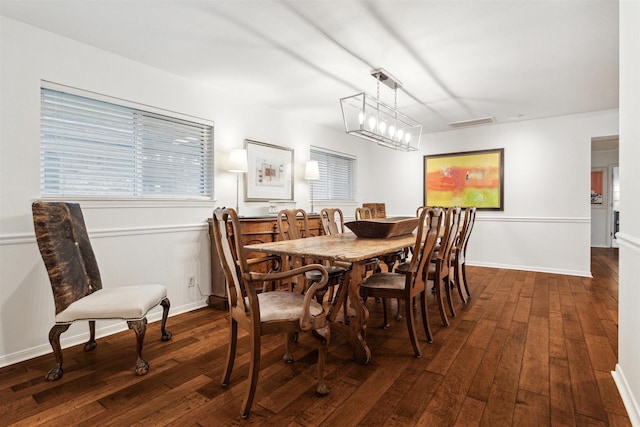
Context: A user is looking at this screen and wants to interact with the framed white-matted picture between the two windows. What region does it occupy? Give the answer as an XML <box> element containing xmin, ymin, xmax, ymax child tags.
<box><xmin>244</xmin><ymin>139</ymin><xmax>293</xmax><ymax>202</ymax></box>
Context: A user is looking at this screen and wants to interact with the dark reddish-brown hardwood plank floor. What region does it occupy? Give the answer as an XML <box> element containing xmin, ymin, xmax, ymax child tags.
<box><xmin>0</xmin><ymin>249</ymin><xmax>630</xmax><ymax>426</ymax></box>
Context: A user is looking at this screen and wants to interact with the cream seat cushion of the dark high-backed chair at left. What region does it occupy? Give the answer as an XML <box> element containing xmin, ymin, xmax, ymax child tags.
<box><xmin>56</xmin><ymin>285</ymin><xmax>167</xmax><ymax>323</ymax></box>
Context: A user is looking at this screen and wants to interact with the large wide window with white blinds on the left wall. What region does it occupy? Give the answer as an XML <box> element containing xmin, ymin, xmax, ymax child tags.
<box><xmin>40</xmin><ymin>85</ymin><xmax>213</xmax><ymax>199</ymax></box>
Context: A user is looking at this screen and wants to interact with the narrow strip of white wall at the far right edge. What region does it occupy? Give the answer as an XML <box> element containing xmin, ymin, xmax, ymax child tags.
<box><xmin>613</xmin><ymin>1</ymin><xmax>640</xmax><ymax>426</ymax></box>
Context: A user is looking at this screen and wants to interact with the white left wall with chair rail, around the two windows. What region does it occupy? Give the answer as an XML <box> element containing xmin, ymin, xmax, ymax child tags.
<box><xmin>0</xmin><ymin>17</ymin><xmax>368</xmax><ymax>366</ymax></box>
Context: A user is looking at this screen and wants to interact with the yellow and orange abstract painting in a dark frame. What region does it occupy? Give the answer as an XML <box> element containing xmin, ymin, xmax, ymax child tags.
<box><xmin>424</xmin><ymin>148</ymin><xmax>504</xmax><ymax>211</ymax></box>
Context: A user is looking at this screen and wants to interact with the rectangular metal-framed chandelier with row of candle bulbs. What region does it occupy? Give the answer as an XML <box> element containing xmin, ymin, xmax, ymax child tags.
<box><xmin>340</xmin><ymin>68</ymin><xmax>422</xmax><ymax>151</ymax></box>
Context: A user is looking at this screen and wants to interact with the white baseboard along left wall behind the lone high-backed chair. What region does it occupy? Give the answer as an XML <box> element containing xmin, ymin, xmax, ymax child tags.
<box><xmin>0</xmin><ymin>300</ymin><xmax>207</xmax><ymax>368</ymax></box>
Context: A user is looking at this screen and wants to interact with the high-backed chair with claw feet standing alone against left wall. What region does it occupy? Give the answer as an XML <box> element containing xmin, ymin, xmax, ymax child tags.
<box><xmin>31</xmin><ymin>201</ymin><xmax>171</xmax><ymax>381</ymax></box>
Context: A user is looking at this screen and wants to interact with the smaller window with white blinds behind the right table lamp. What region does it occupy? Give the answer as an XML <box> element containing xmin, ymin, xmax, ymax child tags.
<box><xmin>311</xmin><ymin>147</ymin><xmax>356</xmax><ymax>200</ymax></box>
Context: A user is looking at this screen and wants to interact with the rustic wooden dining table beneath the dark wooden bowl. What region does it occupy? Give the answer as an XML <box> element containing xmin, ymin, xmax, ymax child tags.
<box><xmin>245</xmin><ymin>232</ymin><xmax>416</xmax><ymax>365</ymax></box>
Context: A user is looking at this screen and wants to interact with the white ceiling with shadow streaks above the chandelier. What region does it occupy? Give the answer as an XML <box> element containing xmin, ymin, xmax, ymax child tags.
<box><xmin>0</xmin><ymin>0</ymin><xmax>618</xmax><ymax>133</ymax></box>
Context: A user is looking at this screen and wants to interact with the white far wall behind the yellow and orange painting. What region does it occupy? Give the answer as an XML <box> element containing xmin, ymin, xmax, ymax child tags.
<box><xmin>367</xmin><ymin>110</ymin><xmax>618</xmax><ymax>276</ymax></box>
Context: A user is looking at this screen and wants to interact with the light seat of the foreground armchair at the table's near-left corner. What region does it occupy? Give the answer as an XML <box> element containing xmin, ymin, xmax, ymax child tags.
<box><xmin>252</xmin><ymin>291</ymin><xmax>323</xmax><ymax>322</ymax></box>
